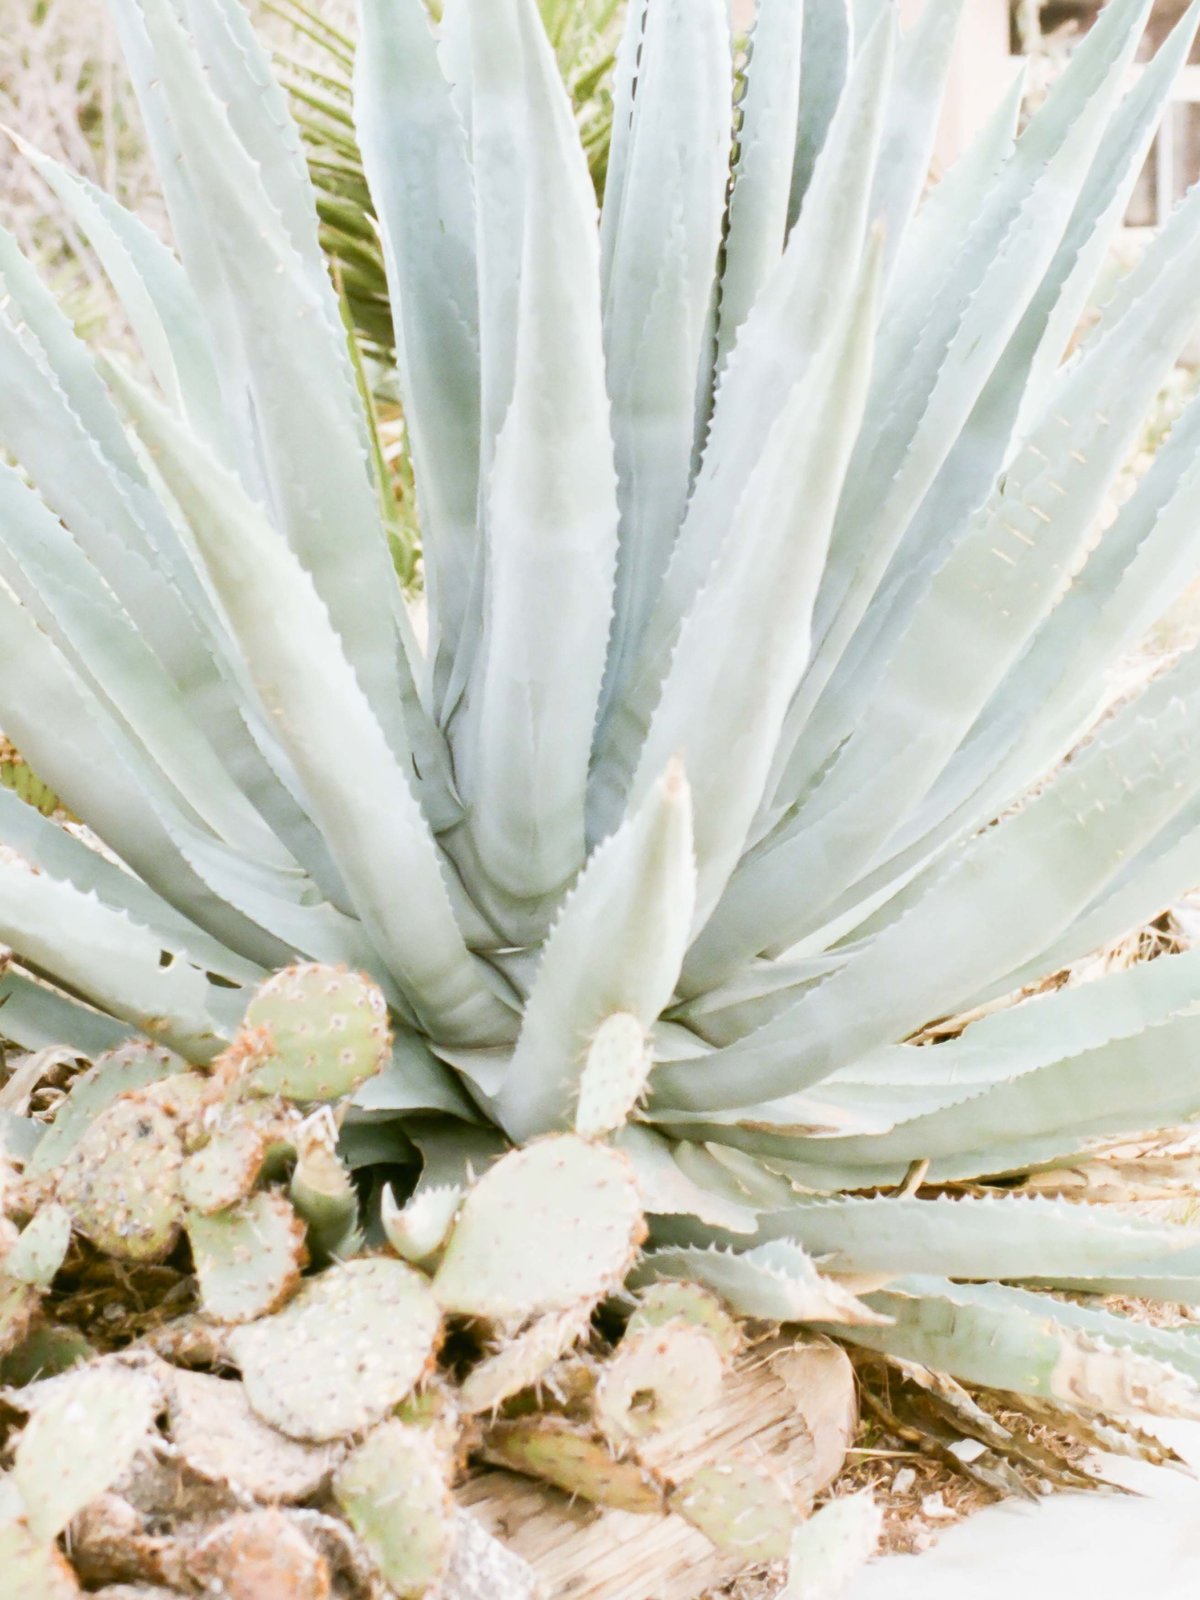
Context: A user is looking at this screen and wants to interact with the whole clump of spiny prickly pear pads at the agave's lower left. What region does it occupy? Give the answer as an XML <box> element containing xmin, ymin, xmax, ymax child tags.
<box><xmin>0</xmin><ymin>965</ymin><xmax>876</xmax><ymax>1600</ymax></box>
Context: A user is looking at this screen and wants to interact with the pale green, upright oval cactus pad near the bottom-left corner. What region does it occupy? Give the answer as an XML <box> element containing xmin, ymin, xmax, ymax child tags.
<box><xmin>13</xmin><ymin>1362</ymin><xmax>162</xmax><ymax>1539</ymax></box>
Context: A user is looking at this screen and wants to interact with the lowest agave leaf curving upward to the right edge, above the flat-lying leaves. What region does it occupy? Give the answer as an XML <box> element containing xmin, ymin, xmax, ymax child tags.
<box><xmin>654</xmin><ymin>658</ymin><xmax>1200</xmax><ymax>1109</ymax></box>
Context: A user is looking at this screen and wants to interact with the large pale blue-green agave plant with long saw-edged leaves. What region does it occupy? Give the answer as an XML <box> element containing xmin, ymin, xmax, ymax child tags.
<box><xmin>0</xmin><ymin>0</ymin><xmax>1200</xmax><ymax>1433</ymax></box>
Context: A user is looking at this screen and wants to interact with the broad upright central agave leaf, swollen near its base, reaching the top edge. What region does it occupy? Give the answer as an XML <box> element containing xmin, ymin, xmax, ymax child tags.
<box><xmin>453</xmin><ymin>0</ymin><xmax>618</xmax><ymax>906</ymax></box>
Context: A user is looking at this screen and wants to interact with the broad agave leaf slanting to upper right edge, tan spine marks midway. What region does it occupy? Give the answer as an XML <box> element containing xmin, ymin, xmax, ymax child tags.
<box><xmin>700</xmin><ymin>144</ymin><xmax>1200</xmax><ymax>962</ymax></box>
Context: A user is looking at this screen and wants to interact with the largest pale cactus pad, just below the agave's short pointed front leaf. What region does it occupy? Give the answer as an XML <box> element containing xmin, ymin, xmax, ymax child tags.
<box><xmin>434</xmin><ymin>1134</ymin><xmax>645</xmax><ymax>1322</ymax></box>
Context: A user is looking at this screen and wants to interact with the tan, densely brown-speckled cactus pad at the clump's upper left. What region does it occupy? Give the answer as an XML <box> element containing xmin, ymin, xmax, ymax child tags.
<box><xmin>56</xmin><ymin>1094</ymin><xmax>184</xmax><ymax>1261</ymax></box>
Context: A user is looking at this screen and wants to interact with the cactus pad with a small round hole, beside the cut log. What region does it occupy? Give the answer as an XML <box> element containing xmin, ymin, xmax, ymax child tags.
<box><xmin>594</xmin><ymin>1322</ymin><xmax>725</xmax><ymax>1443</ymax></box>
